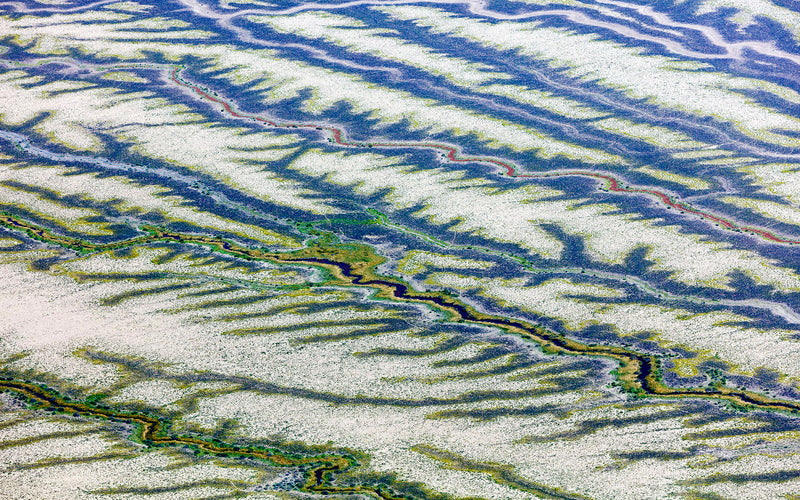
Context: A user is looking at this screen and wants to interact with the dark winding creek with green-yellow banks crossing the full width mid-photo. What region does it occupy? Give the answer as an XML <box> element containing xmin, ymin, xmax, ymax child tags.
<box><xmin>0</xmin><ymin>213</ymin><xmax>800</xmax><ymax>413</ymax></box>
